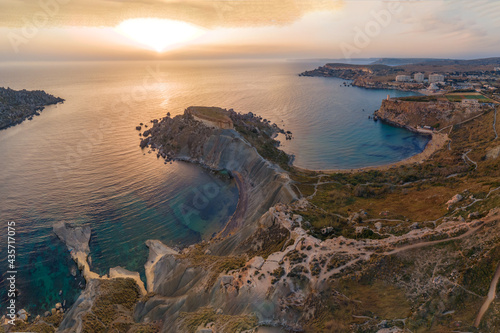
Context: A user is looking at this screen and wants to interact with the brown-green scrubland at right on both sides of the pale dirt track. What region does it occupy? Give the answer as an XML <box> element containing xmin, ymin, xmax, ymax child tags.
<box><xmin>288</xmin><ymin>106</ymin><xmax>500</xmax><ymax>332</ymax></box>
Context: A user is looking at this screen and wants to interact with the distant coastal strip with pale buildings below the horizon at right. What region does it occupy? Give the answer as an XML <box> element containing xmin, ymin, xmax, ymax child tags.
<box><xmin>300</xmin><ymin>58</ymin><xmax>500</xmax><ymax>103</ymax></box>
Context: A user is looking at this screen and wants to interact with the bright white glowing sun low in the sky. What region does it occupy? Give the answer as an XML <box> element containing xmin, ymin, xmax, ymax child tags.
<box><xmin>115</xmin><ymin>18</ymin><xmax>206</xmax><ymax>52</ymax></box>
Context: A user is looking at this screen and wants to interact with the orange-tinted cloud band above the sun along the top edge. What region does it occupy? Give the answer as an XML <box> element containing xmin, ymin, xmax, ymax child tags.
<box><xmin>0</xmin><ymin>0</ymin><xmax>343</xmax><ymax>28</ymax></box>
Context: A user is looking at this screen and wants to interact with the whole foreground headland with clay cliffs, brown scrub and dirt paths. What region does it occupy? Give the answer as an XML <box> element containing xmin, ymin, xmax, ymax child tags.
<box><xmin>5</xmin><ymin>101</ymin><xmax>500</xmax><ymax>333</ymax></box>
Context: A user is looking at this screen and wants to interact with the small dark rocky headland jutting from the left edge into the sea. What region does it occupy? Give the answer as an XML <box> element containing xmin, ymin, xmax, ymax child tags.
<box><xmin>0</xmin><ymin>87</ymin><xmax>64</xmax><ymax>130</ymax></box>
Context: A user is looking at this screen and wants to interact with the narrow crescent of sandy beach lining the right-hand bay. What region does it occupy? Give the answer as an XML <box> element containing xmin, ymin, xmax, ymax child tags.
<box><xmin>293</xmin><ymin>129</ymin><xmax>448</xmax><ymax>174</ymax></box>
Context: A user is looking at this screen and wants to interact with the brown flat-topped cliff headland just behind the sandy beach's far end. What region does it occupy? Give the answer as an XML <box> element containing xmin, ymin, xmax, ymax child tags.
<box><xmin>375</xmin><ymin>99</ymin><xmax>481</xmax><ymax>129</ymax></box>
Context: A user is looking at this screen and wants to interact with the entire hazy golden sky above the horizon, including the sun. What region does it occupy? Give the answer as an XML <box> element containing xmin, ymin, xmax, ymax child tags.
<box><xmin>0</xmin><ymin>0</ymin><xmax>500</xmax><ymax>61</ymax></box>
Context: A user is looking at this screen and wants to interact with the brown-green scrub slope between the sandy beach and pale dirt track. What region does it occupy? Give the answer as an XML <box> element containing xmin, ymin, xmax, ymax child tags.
<box><xmin>292</xmin><ymin>107</ymin><xmax>500</xmax><ymax>232</ymax></box>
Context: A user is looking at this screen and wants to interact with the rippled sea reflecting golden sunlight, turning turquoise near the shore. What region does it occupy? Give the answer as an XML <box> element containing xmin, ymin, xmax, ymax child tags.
<box><xmin>0</xmin><ymin>61</ymin><xmax>427</xmax><ymax>313</ymax></box>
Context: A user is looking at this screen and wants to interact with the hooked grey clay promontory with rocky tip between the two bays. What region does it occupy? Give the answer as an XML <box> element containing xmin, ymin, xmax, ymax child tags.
<box><xmin>141</xmin><ymin>112</ymin><xmax>296</xmax><ymax>255</ymax></box>
